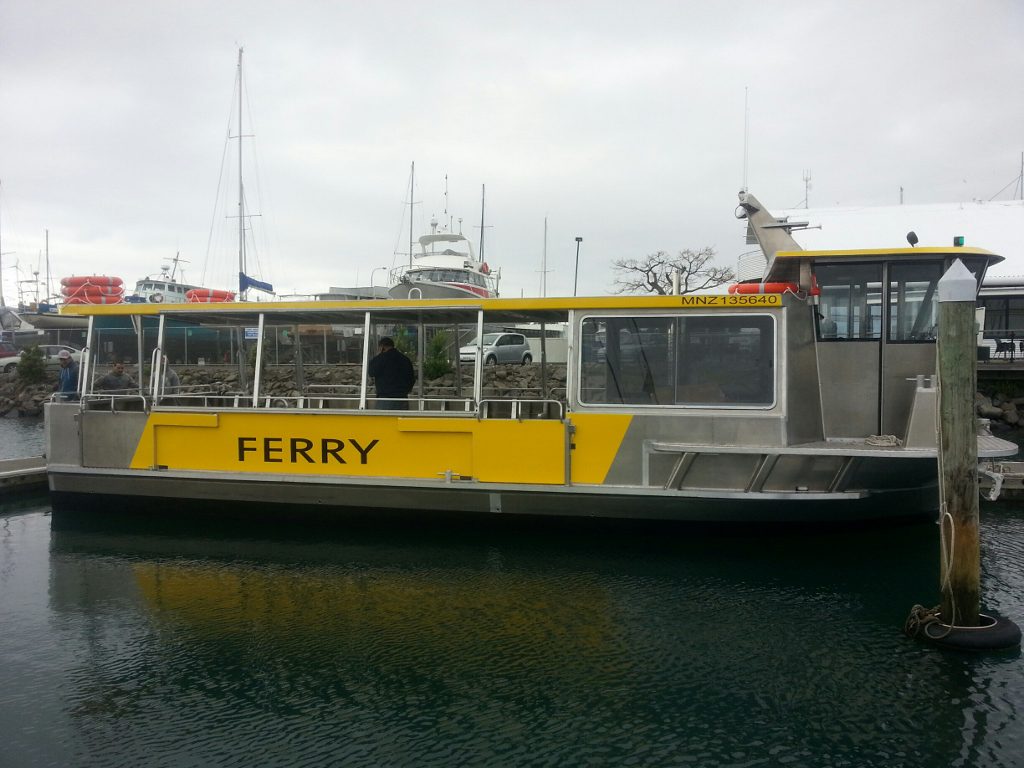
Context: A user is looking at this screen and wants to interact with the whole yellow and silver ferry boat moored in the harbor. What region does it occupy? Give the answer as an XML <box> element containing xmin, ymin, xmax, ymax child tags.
<box><xmin>46</xmin><ymin>195</ymin><xmax>1017</xmax><ymax>523</ymax></box>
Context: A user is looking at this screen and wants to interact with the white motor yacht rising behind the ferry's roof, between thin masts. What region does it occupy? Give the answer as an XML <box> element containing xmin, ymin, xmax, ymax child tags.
<box><xmin>388</xmin><ymin>219</ymin><xmax>498</xmax><ymax>299</ymax></box>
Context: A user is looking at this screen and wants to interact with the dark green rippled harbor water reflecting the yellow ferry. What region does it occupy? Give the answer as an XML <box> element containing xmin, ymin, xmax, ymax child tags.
<box><xmin>0</xmin><ymin>419</ymin><xmax>1024</xmax><ymax>768</ymax></box>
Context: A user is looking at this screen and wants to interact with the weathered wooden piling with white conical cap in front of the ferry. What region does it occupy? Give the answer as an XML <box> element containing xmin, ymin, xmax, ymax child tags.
<box><xmin>938</xmin><ymin>259</ymin><xmax>981</xmax><ymax>627</ymax></box>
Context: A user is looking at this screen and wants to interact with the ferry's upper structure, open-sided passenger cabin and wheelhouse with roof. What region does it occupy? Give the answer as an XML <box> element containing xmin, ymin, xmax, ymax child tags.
<box><xmin>66</xmin><ymin>239</ymin><xmax>998</xmax><ymax>445</ymax></box>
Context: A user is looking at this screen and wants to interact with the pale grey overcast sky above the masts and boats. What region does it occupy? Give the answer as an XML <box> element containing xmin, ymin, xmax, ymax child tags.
<box><xmin>0</xmin><ymin>0</ymin><xmax>1024</xmax><ymax>303</ymax></box>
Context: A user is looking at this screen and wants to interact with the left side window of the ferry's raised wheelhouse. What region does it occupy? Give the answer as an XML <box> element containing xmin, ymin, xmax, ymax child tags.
<box><xmin>814</xmin><ymin>264</ymin><xmax>882</xmax><ymax>341</ymax></box>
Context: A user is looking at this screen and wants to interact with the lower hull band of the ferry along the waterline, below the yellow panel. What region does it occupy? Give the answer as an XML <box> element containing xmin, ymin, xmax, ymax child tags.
<box><xmin>49</xmin><ymin>466</ymin><xmax>938</xmax><ymax>524</ymax></box>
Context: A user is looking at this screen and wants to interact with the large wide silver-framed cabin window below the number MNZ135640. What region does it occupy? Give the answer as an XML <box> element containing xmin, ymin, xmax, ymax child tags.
<box><xmin>580</xmin><ymin>314</ymin><xmax>775</xmax><ymax>408</ymax></box>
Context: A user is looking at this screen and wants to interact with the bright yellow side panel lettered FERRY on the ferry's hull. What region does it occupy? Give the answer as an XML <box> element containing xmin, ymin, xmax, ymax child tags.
<box><xmin>131</xmin><ymin>412</ymin><xmax>631</xmax><ymax>484</ymax></box>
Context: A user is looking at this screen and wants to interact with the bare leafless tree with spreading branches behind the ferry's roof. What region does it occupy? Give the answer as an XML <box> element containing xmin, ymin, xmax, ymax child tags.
<box><xmin>611</xmin><ymin>247</ymin><xmax>736</xmax><ymax>296</ymax></box>
